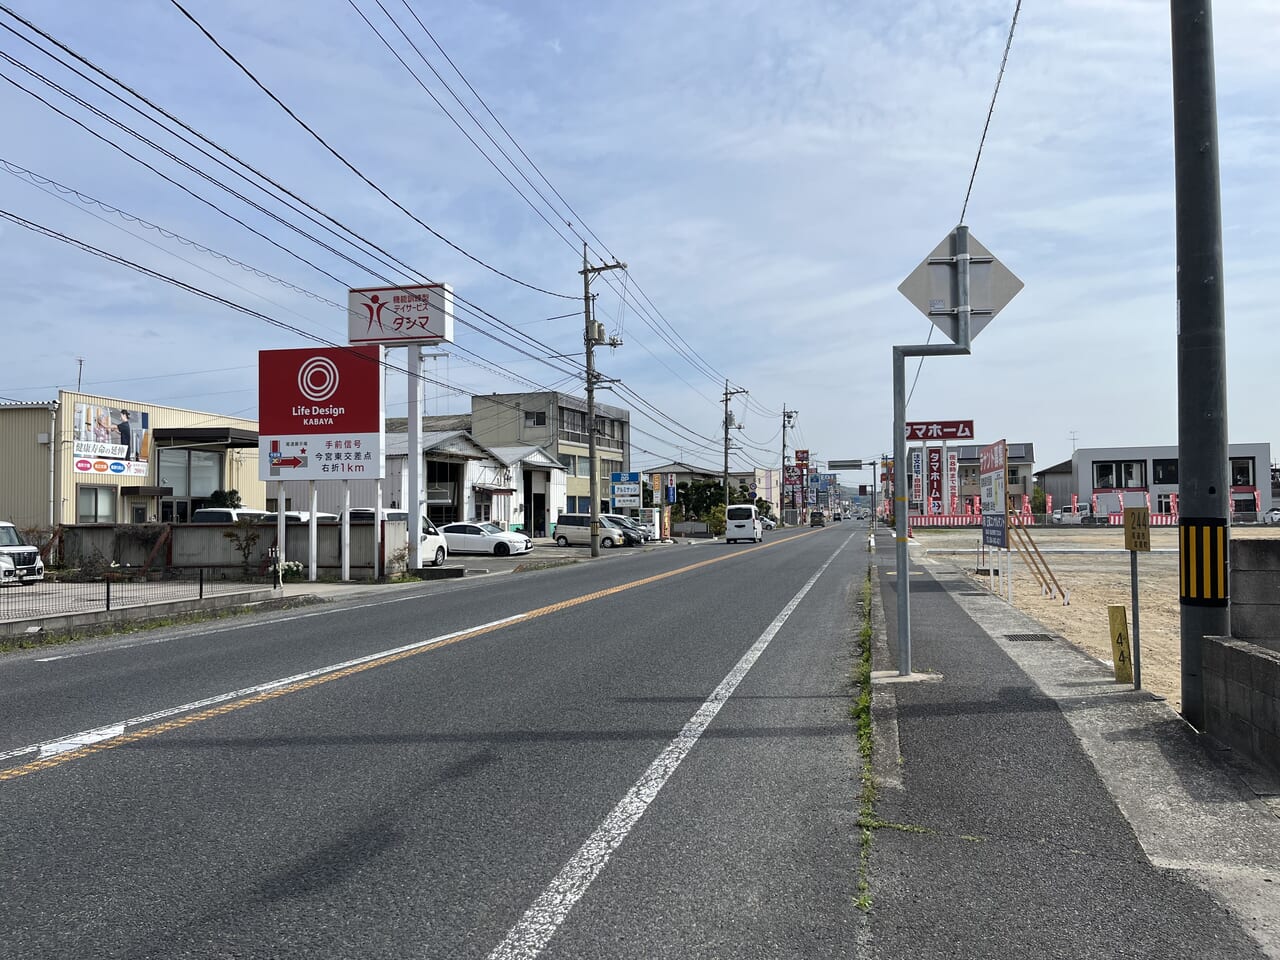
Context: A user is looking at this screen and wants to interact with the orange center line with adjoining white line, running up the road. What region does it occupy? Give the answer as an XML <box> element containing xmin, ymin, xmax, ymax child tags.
<box><xmin>0</xmin><ymin>531</ymin><xmax>829</xmax><ymax>782</ymax></box>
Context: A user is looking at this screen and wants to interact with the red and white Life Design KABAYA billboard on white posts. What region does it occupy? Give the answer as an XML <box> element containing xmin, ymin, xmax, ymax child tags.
<box><xmin>257</xmin><ymin>346</ymin><xmax>387</xmax><ymax>480</ymax></box>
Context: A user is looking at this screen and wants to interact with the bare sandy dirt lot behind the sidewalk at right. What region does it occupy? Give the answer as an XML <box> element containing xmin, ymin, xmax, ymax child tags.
<box><xmin>915</xmin><ymin>526</ymin><xmax>1280</xmax><ymax>709</ymax></box>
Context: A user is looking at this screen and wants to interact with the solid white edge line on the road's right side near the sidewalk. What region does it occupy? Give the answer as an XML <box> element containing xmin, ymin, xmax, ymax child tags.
<box><xmin>489</xmin><ymin>538</ymin><xmax>852</xmax><ymax>960</ymax></box>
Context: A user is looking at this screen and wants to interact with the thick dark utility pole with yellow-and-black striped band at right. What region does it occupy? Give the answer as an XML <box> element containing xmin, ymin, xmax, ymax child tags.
<box><xmin>1170</xmin><ymin>0</ymin><xmax>1231</xmax><ymax>730</ymax></box>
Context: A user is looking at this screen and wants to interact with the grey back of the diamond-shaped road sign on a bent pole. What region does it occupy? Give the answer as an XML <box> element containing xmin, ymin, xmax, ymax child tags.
<box><xmin>897</xmin><ymin>230</ymin><xmax>1023</xmax><ymax>343</ymax></box>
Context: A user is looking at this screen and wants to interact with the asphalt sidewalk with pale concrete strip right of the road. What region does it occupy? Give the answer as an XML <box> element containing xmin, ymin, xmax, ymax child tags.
<box><xmin>870</xmin><ymin>543</ymin><xmax>1280</xmax><ymax>960</ymax></box>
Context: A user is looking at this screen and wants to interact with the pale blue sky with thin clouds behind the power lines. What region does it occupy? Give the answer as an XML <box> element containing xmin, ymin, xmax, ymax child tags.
<box><xmin>0</xmin><ymin>0</ymin><xmax>1280</xmax><ymax>480</ymax></box>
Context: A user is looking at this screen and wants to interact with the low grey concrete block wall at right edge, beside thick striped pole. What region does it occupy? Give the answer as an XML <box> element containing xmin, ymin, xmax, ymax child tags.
<box><xmin>1201</xmin><ymin>640</ymin><xmax>1280</xmax><ymax>776</ymax></box>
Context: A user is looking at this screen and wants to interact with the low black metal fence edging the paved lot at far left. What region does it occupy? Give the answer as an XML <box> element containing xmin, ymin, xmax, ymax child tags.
<box><xmin>0</xmin><ymin>567</ymin><xmax>270</xmax><ymax>622</ymax></box>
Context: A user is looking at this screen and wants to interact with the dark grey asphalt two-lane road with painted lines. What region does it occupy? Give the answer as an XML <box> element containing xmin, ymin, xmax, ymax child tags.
<box><xmin>0</xmin><ymin>524</ymin><xmax>867</xmax><ymax>960</ymax></box>
